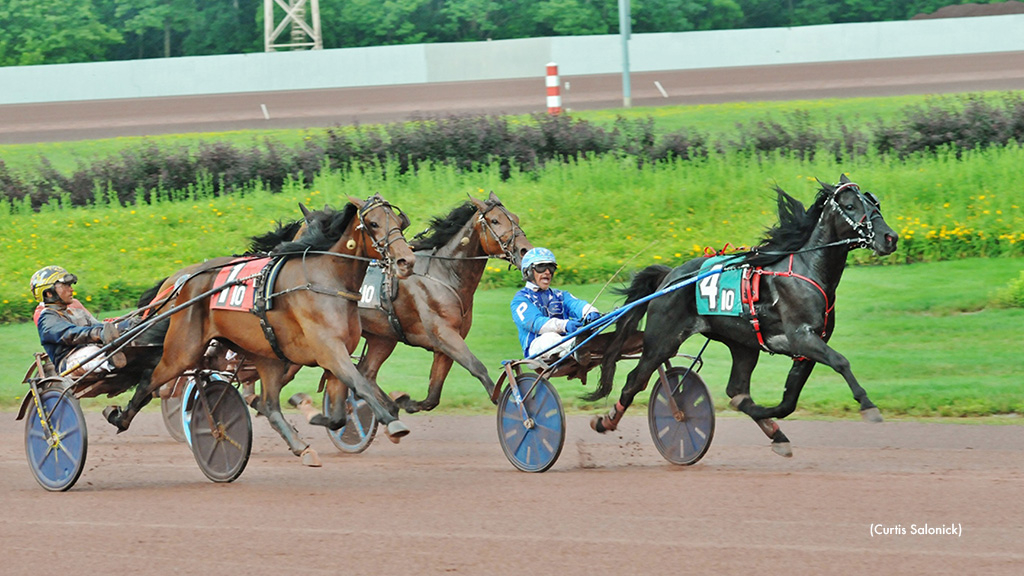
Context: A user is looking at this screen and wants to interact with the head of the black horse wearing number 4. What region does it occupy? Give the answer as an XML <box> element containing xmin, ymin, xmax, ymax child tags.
<box><xmin>819</xmin><ymin>174</ymin><xmax>899</xmax><ymax>256</ymax></box>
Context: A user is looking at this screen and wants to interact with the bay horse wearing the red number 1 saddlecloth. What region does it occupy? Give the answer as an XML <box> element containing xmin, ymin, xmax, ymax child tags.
<box><xmin>104</xmin><ymin>195</ymin><xmax>416</xmax><ymax>461</ymax></box>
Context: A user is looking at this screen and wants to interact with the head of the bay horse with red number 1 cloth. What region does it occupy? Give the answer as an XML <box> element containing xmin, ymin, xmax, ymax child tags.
<box><xmin>348</xmin><ymin>194</ymin><xmax>416</xmax><ymax>278</ymax></box>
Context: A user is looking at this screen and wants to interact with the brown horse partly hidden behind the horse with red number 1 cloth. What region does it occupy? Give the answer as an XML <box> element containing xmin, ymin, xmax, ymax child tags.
<box><xmin>360</xmin><ymin>193</ymin><xmax>534</xmax><ymax>413</ymax></box>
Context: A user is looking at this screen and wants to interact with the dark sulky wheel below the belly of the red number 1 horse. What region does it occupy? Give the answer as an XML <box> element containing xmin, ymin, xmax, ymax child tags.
<box><xmin>185</xmin><ymin>376</ymin><xmax>253</xmax><ymax>482</ymax></box>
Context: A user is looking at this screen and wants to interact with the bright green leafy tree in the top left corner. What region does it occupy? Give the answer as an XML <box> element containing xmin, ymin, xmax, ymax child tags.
<box><xmin>0</xmin><ymin>0</ymin><xmax>121</xmax><ymax>66</ymax></box>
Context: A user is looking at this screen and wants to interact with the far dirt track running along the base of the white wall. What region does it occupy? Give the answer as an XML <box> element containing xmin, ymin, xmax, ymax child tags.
<box><xmin>6</xmin><ymin>52</ymin><xmax>1024</xmax><ymax>143</ymax></box>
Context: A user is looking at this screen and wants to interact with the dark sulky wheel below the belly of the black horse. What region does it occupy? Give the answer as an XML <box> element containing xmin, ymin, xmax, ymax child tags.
<box><xmin>647</xmin><ymin>367</ymin><xmax>715</xmax><ymax>465</ymax></box>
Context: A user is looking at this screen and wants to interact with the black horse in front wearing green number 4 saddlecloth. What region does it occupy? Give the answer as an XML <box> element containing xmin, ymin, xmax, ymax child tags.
<box><xmin>588</xmin><ymin>175</ymin><xmax>899</xmax><ymax>456</ymax></box>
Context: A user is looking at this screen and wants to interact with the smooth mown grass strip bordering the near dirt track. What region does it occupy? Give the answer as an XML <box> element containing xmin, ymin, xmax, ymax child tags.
<box><xmin>0</xmin><ymin>259</ymin><xmax>1024</xmax><ymax>418</ymax></box>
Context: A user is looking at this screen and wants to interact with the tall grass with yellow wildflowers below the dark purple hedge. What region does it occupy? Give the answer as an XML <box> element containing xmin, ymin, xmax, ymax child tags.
<box><xmin>0</xmin><ymin>147</ymin><xmax>1024</xmax><ymax>320</ymax></box>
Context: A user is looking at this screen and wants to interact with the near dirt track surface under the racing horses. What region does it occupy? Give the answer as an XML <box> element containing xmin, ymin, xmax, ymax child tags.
<box><xmin>0</xmin><ymin>409</ymin><xmax>1024</xmax><ymax>576</ymax></box>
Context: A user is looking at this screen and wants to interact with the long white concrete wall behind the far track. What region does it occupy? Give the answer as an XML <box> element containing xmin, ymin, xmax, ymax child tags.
<box><xmin>0</xmin><ymin>14</ymin><xmax>1024</xmax><ymax>105</ymax></box>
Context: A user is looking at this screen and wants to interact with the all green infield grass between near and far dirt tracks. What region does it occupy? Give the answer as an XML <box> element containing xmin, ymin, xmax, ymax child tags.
<box><xmin>0</xmin><ymin>93</ymin><xmax>1024</xmax><ymax>421</ymax></box>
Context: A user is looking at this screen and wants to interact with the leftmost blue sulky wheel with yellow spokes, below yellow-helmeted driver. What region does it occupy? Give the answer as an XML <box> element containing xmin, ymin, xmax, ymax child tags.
<box><xmin>25</xmin><ymin>385</ymin><xmax>89</xmax><ymax>492</ymax></box>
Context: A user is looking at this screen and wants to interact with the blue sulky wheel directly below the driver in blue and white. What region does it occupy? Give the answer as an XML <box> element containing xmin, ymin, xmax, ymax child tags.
<box><xmin>498</xmin><ymin>374</ymin><xmax>565</xmax><ymax>472</ymax></box>
